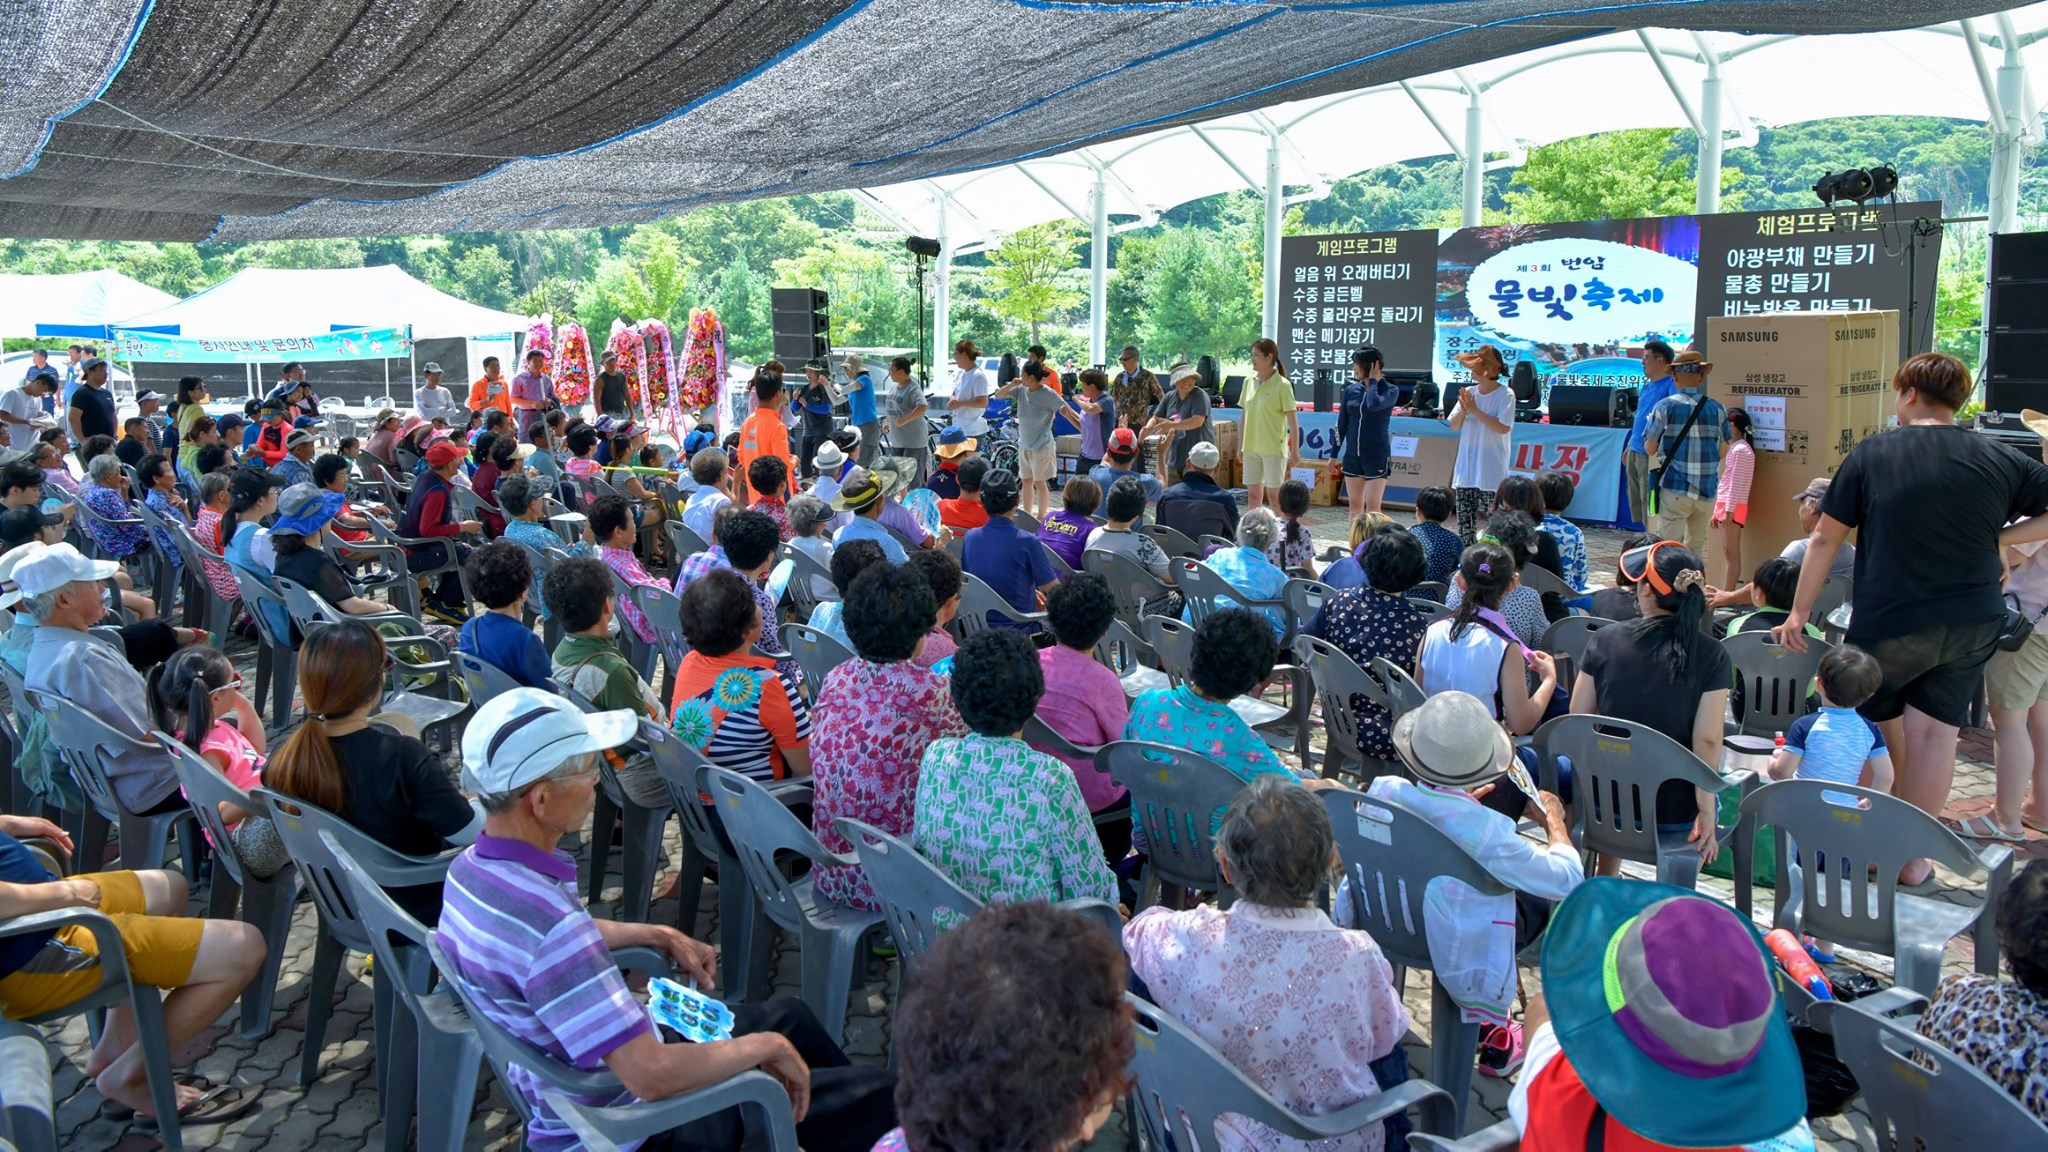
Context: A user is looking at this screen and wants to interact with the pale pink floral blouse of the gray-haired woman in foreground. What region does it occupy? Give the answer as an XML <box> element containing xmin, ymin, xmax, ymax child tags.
<box><xmin>1124</xmin><ymin>900</ymin><xmax>1409</xmax><ymax>1152</ymax></box>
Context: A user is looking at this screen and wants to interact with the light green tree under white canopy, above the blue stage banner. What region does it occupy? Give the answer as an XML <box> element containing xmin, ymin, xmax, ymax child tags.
<box><xmin>1507</xmin><ymin>127</ymin><xmax>1741</xmax><ymax>223</ymax></box>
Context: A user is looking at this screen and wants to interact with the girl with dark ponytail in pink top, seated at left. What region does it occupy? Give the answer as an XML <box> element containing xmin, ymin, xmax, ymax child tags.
<box><xmin>150</xmin><ymin>644</ymin><xmax>291</xmax><ymax>879</ymax></box>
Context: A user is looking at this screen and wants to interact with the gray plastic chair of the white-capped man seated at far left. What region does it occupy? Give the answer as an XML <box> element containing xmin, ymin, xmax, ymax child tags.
<box><xmin>29</xmin><ymin>691</ymin><xmax>199</xmax><ymax>881</ymax></box>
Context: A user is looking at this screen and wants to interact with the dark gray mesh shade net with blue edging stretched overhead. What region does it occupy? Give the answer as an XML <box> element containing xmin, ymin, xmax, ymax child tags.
<box><xmin>0</xmin><ymin>0</ymin><xmax>1993</xmax><ymax>242</ymax></box>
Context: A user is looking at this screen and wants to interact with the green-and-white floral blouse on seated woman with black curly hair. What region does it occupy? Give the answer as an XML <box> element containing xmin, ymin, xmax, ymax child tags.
<box><xmin>913</xmin><ymin>734</ymin><xmax>1116</xmax><ymax>904</ymax></box>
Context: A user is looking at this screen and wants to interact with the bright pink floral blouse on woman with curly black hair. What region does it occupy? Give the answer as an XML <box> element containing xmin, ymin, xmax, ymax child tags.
<box><xmin>811</xmin><ymin>656</ymin><xmax>967</xmax><ymax>908</ymax></box>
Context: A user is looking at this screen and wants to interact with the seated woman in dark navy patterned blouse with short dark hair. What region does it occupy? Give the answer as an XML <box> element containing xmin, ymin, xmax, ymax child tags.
<box><xmin>1303</xmin><ymin>525</ymin><xmax>1430</xmax><ymax>760</ymax></box>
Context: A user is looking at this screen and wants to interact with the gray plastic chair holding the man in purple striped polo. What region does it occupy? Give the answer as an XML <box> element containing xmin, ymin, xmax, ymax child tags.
<box><xmin>426</xmin><ymin>935</ymin><xmax>799</xmax><ymax>1152</ymax></box>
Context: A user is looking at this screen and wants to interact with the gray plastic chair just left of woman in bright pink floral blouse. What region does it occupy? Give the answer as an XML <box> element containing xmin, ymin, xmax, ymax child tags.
<box><xmin>696</xmin><ymin>767</ymin><xmax>883</xmax><ymax>1043</ymax></box>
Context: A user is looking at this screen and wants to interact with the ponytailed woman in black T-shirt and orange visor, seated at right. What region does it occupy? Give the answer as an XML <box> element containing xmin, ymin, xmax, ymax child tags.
<box><xmin>1571</xmin><ymin>539</ymin><xmax>1733</xmax><ymax>875</ymax></box>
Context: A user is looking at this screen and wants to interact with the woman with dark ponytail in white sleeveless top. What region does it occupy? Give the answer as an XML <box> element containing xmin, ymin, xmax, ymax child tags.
<box><xmin>1415</xmin><ymin>543</ymin><xmax>1556</xmax><ymax>736</ymax></box>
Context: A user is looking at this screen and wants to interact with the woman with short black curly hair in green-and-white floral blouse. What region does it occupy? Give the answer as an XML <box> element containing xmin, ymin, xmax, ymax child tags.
<box><xmin>913</xmin><ymin>627</ymin><xmax>1116</xmax><ymax>904</ymax></box>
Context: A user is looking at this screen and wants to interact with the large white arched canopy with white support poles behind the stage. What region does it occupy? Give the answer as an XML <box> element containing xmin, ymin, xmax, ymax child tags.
<box><xmin>858</xmin><ymin>4</ymin><xmax>2048</xmax><ymax>363</ymax></box>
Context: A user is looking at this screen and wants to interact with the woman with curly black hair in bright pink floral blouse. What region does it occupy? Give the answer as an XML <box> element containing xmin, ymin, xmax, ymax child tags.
<box><xmin>811</xmin><ymin>557</ymin><xmax>967</xmax><ymax>908</ymax></box>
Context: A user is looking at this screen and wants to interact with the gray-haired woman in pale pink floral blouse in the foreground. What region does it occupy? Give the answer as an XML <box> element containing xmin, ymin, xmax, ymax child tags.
<box><xmin>1124</xmin><ymin>777</ymin><xmax>1409</xmax><ymax>1152</ymax></box>
